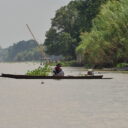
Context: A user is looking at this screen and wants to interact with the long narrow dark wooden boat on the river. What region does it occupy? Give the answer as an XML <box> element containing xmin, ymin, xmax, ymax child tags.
<box><xmin>1</xmin><ymin>74</ymin><xmax>103</xmax><ymax>79</ymax></box>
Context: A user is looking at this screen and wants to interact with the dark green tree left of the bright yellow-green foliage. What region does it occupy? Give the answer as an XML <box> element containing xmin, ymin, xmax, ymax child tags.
<box><xmin>44</xmin><ymin>0</ymin><xmax>107</xmax><ymax>59</ymax></box>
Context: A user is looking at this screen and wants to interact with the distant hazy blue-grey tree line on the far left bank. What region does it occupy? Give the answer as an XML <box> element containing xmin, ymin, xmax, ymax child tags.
<box><xmin>0</xmin><ymin>40</ymin><xmax>41</xmax><ymax>61</ymax></box>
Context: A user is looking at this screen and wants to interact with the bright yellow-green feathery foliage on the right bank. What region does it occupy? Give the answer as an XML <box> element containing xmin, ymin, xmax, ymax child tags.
<box><xmin>76</xmin><ymin>0</ymin><xmax>128</xmax><ymax>67</ymax></box>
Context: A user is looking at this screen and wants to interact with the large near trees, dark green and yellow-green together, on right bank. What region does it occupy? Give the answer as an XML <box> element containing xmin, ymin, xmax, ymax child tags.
<box><xmin>44</xmin><ymin>0</ymin><xmax>128</xmax><ymax>68</ymax></box>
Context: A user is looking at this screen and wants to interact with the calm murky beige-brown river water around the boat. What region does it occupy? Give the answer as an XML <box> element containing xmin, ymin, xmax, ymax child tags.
<box><xmin>0</xmin><ymin>63</ymin><xmax>128</xmax><ymax>128</ymax></box>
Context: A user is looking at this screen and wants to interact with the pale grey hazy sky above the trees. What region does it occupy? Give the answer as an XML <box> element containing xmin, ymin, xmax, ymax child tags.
<box><xmin>0</xmin><ymin>0</ymin><xmax>71</xmax><ymax>48</ymax></box>
